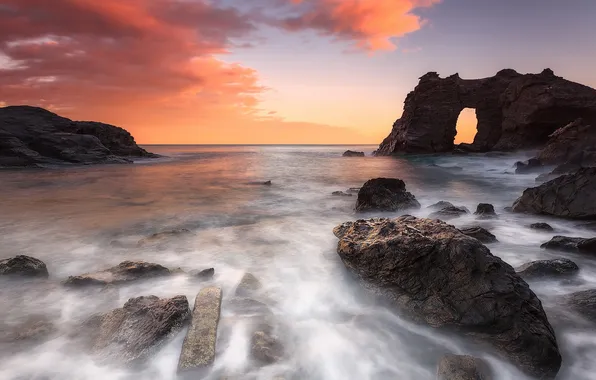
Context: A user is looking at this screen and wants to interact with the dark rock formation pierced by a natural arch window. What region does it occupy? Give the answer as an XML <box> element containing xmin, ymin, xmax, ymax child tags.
<box><xmin>375</xmin><ymin>69</ymin><xmax>596</xmax><ymax>156</ymax></box>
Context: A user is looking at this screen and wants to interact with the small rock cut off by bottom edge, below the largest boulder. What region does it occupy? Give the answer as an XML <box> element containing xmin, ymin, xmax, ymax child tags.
<box><xmin>437</xmin><ymin>355</ymin><xmax>492</xmax><ymax>380</ymax></box>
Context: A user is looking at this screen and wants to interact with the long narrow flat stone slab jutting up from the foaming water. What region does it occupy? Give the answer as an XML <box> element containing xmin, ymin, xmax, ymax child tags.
<box><xmin>178</xmin><ymin>286</ymin><xmax>222</xmax><ymax>372</ymax></box>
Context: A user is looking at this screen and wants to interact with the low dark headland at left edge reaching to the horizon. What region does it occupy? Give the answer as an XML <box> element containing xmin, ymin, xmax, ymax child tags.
<box><xmin>0</xmin><ymin>106</ymin><xmax>158</xmax><ymax>167</ymax></box>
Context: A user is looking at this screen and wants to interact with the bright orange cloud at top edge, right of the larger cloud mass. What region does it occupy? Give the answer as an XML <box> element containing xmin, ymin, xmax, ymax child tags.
<box><xmin>283</xmin><ymin>0</ymin><xmax>441</xmax><ymax>51</ymax></box>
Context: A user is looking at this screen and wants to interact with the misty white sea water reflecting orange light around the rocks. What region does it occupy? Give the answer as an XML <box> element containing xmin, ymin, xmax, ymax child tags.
<box><xmin>0</xmin><ymin>146</ymin><xmax>596</xmax><ymax>380</ymax></box>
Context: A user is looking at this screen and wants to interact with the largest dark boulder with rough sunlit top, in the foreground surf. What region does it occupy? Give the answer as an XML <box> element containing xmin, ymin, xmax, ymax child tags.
<box><xmin>334</xmin><ymin>215</ymin><xmax>561</xmax><ymax>379</ymax></box>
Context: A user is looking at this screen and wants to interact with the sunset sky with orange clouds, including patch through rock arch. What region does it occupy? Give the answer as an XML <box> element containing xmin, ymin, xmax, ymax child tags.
<box><xmin>0</xmin><ymin>0</ymin><xmax>596</xmax><ymax>144</ymax></box>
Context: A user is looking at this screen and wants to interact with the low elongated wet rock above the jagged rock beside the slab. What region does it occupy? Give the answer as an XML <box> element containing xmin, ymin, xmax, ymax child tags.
<box><xmin>64</xmin><ymin>261</ymin><xmax>172</xmax><ymax>287</ymax></box>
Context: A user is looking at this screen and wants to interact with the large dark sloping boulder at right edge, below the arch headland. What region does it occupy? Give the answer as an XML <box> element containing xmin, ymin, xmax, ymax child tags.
<box><xmin>512</xmin><ymin>168</ymin><xmax>596</xmax><ymax>219</ymax></box>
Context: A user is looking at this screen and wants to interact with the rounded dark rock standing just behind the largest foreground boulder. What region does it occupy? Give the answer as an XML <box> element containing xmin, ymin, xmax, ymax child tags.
<box><xmin>356</xmin><ymin>178</ymin><xmax>420</xmax><ymax>212</ymax></box>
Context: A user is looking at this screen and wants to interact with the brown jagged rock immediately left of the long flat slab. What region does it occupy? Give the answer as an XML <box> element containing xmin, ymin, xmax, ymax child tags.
<box><xmin>80</xmin><ymin>296</ymin><xmax>190</xmax><ymax>365</ymax></box>
